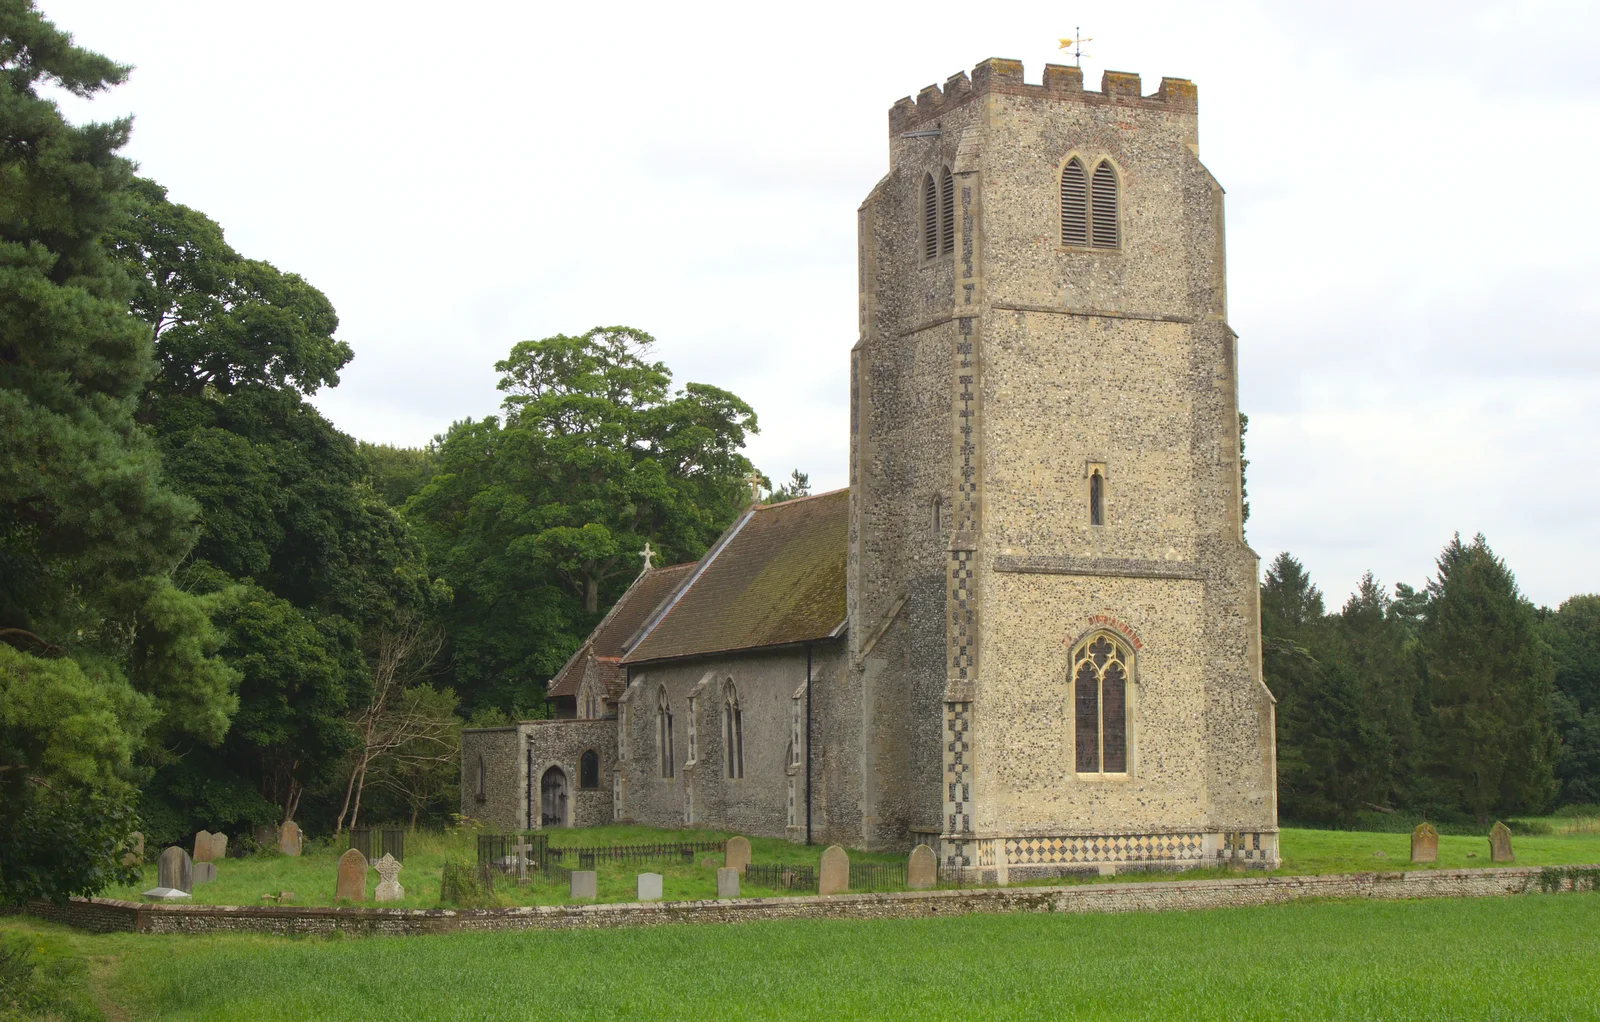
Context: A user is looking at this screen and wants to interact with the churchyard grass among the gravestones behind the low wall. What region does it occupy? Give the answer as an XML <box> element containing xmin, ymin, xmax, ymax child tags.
<box><xmin>106</xmin><ymin>819</ymin><xmax>1600</xmax><ymax>908</ymax></box>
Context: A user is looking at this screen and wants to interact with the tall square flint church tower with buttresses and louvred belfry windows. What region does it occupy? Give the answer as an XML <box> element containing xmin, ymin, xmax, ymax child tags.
<box><xmin>851</xmin><ymin>59</ymin><xmax>1278</xmax><ymax>880</ymax></box>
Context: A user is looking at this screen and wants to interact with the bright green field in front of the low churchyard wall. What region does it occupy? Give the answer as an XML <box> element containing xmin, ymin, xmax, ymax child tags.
<box><xmin>0</xmin><ymin>892</ymin><xmax>1600</xmax><ymax>1022</ymax></box>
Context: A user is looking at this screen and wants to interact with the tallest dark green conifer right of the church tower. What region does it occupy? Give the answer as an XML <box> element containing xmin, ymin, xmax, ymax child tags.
<box><xmin>1421</xmin><ymin>534</ymin><xmax>1557</xmax><ymax>817</ymax></box>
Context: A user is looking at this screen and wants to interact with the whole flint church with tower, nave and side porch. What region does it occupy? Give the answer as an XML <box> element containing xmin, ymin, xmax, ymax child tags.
<box><xmin>461</xmin><ymin>59</ymin><xmax>1278</xmax><ymax>883</ymax></box>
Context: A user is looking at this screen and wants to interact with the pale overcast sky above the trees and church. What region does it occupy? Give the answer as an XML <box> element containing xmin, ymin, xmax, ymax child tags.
<box><xmin>40</xmin><ymin>0</ymin><xmax>1600</xmax><ymax>605</ymax></box>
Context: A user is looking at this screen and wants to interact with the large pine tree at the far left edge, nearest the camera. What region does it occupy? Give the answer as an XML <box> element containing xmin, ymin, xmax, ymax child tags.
<box><xmin>0</xmin><ymin>0</ymin><xmax>235</xmax><ymax>900</ymax></box>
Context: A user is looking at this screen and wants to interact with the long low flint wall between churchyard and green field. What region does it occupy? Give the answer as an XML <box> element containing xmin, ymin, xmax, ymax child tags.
<box><xmin>22</xmin><ymin>865</ymin><xmax>1600</xmax><ymax>936</ymax></box>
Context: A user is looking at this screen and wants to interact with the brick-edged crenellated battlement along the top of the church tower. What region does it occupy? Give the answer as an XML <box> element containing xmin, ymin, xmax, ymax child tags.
<box><xmin>890</xmin><ymin>58</ymin><xmax>1200</xmax><ymax>134</ymax></box>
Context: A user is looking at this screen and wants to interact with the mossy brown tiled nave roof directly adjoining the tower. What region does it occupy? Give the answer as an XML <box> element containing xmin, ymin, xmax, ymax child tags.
<box><xmin>622</xmin><ymin>489</ymin><xmax>850</xmax><ymax>664</ymax></box>
